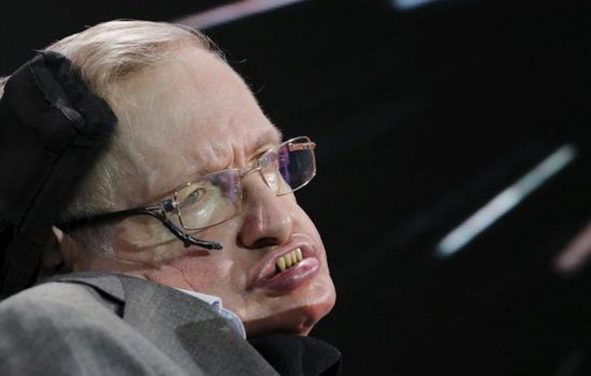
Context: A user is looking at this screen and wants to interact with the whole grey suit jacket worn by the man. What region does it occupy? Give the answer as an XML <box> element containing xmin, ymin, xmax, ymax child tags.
<box><xmin>0</xmin><ymin>273</ymin><xmax>277</xmax><ymax>376</ymax></box>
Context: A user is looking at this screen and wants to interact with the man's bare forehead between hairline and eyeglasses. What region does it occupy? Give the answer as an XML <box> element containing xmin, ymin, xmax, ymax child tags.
<box><xmin>115</xmin><ymin>47</ymin><xmax>281</xmax><ymax>194</ymax></box>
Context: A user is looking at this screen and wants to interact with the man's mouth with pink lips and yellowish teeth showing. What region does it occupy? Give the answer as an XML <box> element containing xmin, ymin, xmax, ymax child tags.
<box><xmin>251</xmin><ymin>241</ymin><xmax>320</xmax><ymax>296</ymax></box>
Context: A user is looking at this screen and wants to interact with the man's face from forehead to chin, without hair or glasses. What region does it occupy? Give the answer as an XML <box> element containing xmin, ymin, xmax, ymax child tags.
<box><xmin>90</xmin><ymin>47</ymin><xmax>335</xmax><ymax>336</ymax></box>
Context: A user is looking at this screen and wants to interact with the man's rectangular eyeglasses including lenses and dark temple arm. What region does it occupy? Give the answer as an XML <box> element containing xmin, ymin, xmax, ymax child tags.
<box><xmin>57</xmin><ymin>136</ymin><xmax>316</xmax><ymax>249</ymax></box>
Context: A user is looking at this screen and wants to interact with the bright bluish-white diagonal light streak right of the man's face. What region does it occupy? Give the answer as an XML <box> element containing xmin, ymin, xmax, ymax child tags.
<box><xmin>436</xmin><ymin>144</ymin><xmax>577</xmax><ymax>257</ymax></box>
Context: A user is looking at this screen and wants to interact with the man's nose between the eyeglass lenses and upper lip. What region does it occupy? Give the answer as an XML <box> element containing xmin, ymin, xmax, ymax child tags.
<box><xmin>238</xmin><ymin>173</ymin><xmax>295</xmax><ymax>249</ymax></box>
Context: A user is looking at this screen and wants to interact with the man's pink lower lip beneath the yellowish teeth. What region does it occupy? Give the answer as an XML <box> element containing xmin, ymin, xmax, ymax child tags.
<box><xmin>253</xmin><ymin>257</ymin><xmax>320</xmax><ymax>295</ymax></box>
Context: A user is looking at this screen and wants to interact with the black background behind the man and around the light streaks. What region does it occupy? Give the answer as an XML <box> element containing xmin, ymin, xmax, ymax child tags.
<box><xmin>0</xmin><ymin>0</ymin><xmax>591</xmax><ymax>376</ymax></box>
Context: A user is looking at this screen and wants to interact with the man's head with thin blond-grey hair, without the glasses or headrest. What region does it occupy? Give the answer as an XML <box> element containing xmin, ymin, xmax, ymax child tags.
<box><xmin>34</xmin><ymin>21</ymin><xmax>335</xmax><ymax>336</ymax></box>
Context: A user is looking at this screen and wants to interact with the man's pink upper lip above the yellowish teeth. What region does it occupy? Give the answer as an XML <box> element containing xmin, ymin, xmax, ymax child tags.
<box><xmin>250</xmin><ymin>235</ymin><xmax>316</xmax><ymax>286</ymax></box>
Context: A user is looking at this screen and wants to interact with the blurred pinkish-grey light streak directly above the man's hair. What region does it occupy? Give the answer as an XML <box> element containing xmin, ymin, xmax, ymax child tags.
<box><xmin>173</xmin><ymin>0</ymin><xmax>309</xmax><ymax>29</ymax></box>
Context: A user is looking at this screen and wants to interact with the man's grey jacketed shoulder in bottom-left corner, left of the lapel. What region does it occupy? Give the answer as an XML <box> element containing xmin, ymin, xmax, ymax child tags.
<box><xmin>0</xmin><ymin>282</ymin><xmax>185</xmax><ymax>376</ymax></box>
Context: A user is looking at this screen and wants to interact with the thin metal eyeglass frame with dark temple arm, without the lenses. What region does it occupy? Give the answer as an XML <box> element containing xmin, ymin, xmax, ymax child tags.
<box><xmin>56</xmin><ymin>136</ymin><xmax>316</xmax><ymax>250</ymax></box>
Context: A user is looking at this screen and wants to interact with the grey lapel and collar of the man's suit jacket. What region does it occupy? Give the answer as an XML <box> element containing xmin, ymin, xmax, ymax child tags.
<box><xmin>47</xmin><ymin>273</ymin><xmax>277</xmax><ymax>375</ymax></box>
